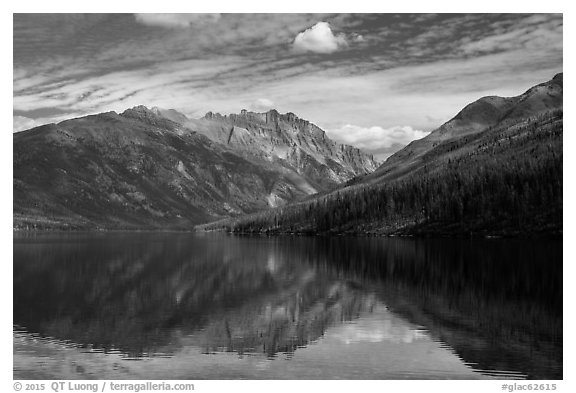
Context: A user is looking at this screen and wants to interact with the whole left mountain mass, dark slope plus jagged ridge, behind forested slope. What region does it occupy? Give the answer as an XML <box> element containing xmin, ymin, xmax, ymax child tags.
<box><xmin>13</xmin><ymin>106</ymin><xmax>376</xmax><ymax>229</ymax></box>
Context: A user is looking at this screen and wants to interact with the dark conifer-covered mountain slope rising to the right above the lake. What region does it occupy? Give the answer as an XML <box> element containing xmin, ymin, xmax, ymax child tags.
<box><xmin>203</xmin><ymin>74</ymin><xmax>563</xmax><ymax>235</ymax></box>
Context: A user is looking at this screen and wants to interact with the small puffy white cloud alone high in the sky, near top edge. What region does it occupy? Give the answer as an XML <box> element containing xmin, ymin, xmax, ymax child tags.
<box><xmin>293</xmin><ymin>22</ymin><xmax>348</xmax><ymax>53</ymax></box>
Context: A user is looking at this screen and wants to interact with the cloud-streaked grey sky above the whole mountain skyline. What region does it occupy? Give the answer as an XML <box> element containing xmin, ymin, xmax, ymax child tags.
<box><xmin>13</xmin><ymin>13</ymin><xmax>563</xmax><ymax>160</ymax></box>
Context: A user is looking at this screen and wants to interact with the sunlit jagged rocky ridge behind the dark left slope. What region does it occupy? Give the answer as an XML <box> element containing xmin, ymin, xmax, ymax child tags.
<box><xmin>154</xmin><ymin>108</ymin><xmax>379</xmax><ymax>193</ymax></box>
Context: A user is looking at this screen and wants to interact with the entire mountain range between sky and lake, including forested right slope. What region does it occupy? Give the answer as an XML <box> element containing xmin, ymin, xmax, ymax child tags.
<box><xmin>13</xmin><ymin>74</ymin><xmax>563</xmax><ymax>235</ymax></box>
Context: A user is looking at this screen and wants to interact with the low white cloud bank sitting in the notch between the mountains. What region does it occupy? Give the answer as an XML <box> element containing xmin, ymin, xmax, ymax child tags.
<box><xmin>327</xmin><ymin>124</ymin><xmax>429</xmax><ymax>159</ymax></box>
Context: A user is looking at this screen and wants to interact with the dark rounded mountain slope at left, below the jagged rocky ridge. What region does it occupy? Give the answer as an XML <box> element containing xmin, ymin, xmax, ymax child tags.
<box><xmin>13</xmin><ymin>110</ymin><xmax>274</xmax><ymax>228</ymax></box>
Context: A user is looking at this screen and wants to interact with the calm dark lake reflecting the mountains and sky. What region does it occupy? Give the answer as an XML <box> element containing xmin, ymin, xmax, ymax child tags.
<box><xmin>13</xmin><ymin>233</ymin><xmax>562</xmax><ymax>380</ymax></box>
